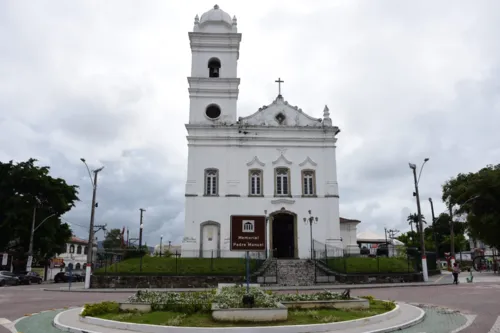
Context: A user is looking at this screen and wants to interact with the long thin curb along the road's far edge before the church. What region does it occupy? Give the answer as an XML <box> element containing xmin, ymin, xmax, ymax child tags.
<box><xmin>42</xmin><ymin>282</ymin><xmax>453</xmax><ymax>293</ymax></box>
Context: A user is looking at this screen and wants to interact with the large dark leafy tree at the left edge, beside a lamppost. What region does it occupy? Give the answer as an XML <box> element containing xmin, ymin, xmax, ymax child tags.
<box><xmin>0</xmin><ymin>159</ymin><xmax>78</xmax><ymax>261</ymax></box>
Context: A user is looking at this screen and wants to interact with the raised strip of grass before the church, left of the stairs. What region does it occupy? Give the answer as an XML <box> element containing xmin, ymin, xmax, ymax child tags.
<box><xmin>95</xmin><ymin>256</ymin><xmax>258</xmax><ymax>276</ymax></box>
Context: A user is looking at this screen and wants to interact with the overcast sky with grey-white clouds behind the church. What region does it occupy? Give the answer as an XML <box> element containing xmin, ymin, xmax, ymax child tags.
<box><xmin>0</xmin><ymin>0</ymin><xmax>500</xmax><ymax>245</ymax></box>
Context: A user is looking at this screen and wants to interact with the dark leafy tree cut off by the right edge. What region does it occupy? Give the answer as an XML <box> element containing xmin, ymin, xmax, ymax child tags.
<box><xmin>442</xmin><ymin>164</ymin><xmax>500</xmax><ymax>248</ymax></box>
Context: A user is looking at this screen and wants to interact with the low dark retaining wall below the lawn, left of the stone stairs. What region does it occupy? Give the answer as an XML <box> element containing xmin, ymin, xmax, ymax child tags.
<box><xmin>90</xmin><ymin>275</ymin><xmax>245</xmax><ymax>288</ymax></box>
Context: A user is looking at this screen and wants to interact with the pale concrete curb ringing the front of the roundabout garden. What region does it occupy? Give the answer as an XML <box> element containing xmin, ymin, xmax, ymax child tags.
<box><xmin>54</xmin><ymin>303</ymin><xmax>425</xmax><ymax>333</ymax></box>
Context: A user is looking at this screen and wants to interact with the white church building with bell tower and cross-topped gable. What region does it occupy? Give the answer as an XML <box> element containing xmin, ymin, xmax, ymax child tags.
<box><xmin>181</xmin><ymin>5</ymin><xmax>359</xmax><ymax>258</ymax></box>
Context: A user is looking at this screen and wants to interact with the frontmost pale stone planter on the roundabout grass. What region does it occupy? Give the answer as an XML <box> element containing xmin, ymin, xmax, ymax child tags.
<box><xmin>212</xmin><ymin>303</ymin><xmax>288</xmax><ymax>322</ymax></box>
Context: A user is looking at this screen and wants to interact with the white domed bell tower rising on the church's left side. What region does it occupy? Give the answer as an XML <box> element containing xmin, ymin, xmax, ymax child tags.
<box><xmin>188</xmin><ymin>5</ymin><xmax>241</xmax><ymax>124</ymax></box>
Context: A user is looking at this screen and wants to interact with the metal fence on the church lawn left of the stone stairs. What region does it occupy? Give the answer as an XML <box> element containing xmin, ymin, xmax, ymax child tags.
<box><xmin>94</xmin><ymin>249</ymin><xmax>266</xmax><ymax>276</ymax></box>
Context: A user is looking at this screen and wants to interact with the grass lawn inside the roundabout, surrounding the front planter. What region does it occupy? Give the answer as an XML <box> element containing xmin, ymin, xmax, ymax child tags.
<box><xmin>99</xmin><ymin>300</ymin><xmax>390</xmax><ymax>327</ymax></box>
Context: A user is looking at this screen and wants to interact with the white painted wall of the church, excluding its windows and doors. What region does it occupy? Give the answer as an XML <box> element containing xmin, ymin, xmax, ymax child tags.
<box><xmin>182</xmin><ymin>5</ymin><xmax>350</xmax><ymax>258</ymax></box>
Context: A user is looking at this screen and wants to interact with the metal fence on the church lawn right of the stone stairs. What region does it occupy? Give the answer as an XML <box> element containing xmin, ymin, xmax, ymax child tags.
<box><xmin>313</xmin><ymin>240</ymin><xmax>418</xmax><ymax>274</ymax></box>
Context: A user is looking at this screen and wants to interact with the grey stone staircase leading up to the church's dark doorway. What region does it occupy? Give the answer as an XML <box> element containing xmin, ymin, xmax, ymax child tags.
<box><xmin>276</xmin><ymin>259</ymin><xmax>314</xmax><ymax>286</ymax></box>
